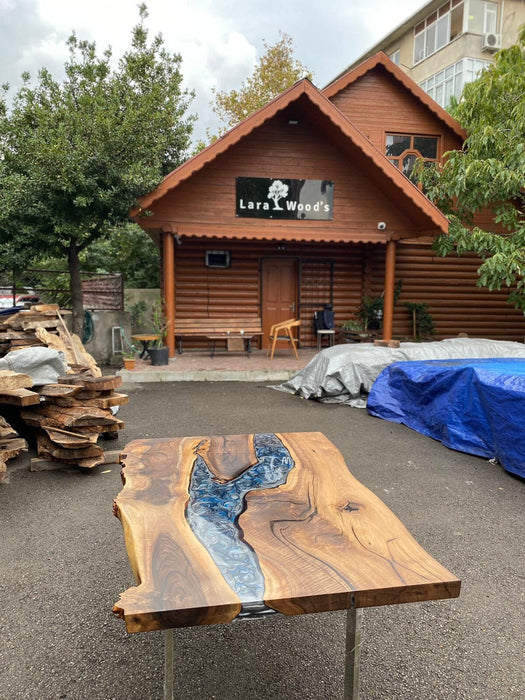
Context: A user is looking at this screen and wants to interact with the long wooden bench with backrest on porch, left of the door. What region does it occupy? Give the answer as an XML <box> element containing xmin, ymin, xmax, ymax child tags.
<box><xmin>175</xmin><ymin>316</ymin><xmax>262</xmax><ymax>354</ymax></box>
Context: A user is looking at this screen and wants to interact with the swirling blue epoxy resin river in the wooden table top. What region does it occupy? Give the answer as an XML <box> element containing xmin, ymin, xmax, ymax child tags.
<box><xmin>186</xmin><ymin>433</ymin><xmax>294</xmax><ymax>603</ymax></box>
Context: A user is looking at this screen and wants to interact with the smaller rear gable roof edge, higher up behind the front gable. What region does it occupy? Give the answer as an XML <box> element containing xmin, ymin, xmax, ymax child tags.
<box><xmin>322</xmin><ymin>51</ymin><xmax>467</xmax><ymax>141</ymax></box>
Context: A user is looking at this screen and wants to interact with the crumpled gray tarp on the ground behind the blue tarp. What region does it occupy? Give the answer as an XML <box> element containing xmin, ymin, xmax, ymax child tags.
<box><xmin>273</xmin><ymin>338</ymin><xmax>525</xmax><ymax>408</ymax></box>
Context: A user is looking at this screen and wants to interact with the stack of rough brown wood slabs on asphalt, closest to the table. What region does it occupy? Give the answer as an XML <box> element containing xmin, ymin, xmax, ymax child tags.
<box><xmin>22</xmin><ymin>374</ymin><xmax>129</xmax><ymax>468</ymax></box>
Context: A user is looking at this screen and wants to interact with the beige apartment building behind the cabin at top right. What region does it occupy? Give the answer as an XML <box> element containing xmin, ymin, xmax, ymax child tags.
<box><xmin>338</xmin><ymin>0</ymin><xmax>525</xmax><ymax>108</ymax></box>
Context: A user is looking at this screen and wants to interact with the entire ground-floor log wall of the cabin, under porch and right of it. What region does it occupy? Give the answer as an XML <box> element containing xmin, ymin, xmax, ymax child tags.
<box><xmin>170</xmin><ymin>239</ymin><xmax>525</xmax><ymax>347</ymax></box>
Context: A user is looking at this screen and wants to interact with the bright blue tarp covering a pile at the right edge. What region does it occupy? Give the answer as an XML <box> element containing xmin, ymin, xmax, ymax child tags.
<box><xmin>367</xmin><ymin>358</ymin><xmax>525</xmax><ymax>477</ymax></box>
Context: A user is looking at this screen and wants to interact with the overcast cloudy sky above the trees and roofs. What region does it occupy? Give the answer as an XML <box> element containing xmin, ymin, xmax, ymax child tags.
<box><xmin>0</xmin><ymin>0</ymin><xmax>425</xmax><ymax>142</ymax></box>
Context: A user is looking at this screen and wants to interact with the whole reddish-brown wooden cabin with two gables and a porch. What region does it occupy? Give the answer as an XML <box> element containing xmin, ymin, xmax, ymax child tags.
<box><xmin>133</xmin><ymin>53</ymin><xmax>523</xmax><ymax>354</ymax></box>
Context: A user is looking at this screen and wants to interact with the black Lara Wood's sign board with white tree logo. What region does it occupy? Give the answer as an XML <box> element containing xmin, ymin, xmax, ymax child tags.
<box><xmin>235</xmin><ymin>177</ymin><xmax>334</xmax><ymax>221</ymax></box>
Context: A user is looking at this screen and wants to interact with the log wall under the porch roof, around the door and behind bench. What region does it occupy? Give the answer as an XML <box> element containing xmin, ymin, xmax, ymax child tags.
<box><xmin>171</xmin><ymin>239</ymin><xmax>363</xmax><ymax>347</ymax></box>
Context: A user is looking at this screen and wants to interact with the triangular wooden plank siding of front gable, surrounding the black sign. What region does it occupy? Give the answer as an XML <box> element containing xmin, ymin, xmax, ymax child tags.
<box><xmin>145</xmin><ymin>108</ymin><xmax>440</xmax><ymax>242</ymax></box>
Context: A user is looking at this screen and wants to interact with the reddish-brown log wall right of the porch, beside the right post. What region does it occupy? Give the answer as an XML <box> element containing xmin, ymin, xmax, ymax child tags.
<box><xmin>370</xmin><ymin>244</ymin><xmax>525</xmax><ymax>342</ymax></box>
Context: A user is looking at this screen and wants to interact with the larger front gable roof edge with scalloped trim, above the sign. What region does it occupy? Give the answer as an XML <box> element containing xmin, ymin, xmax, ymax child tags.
<box><xmin>131</xmin><ymin>73</ymin><xmax>448</xmax><ymax>233</ymax></box>
